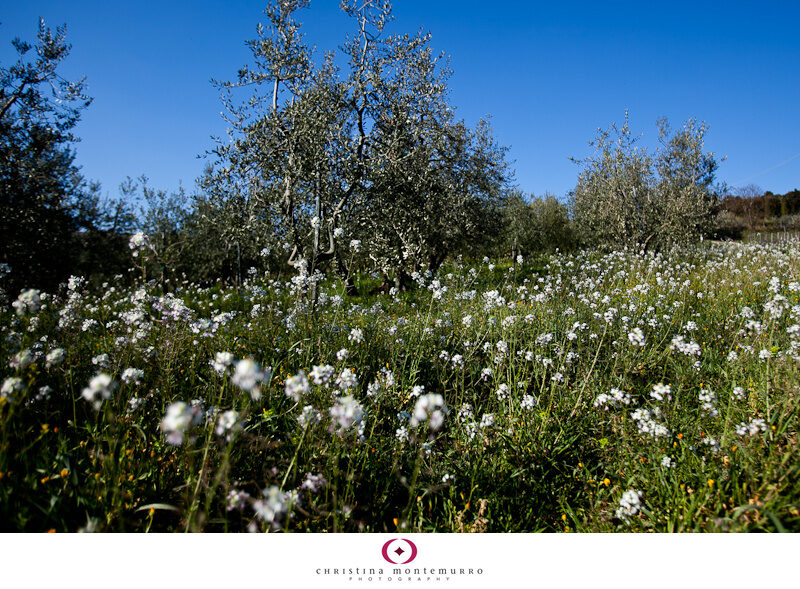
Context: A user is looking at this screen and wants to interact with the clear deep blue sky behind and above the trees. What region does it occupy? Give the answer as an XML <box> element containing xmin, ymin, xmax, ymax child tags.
<box><xmin>0</xmin><ymin>0</ymin><xmax>800</xmax><ymax>196</ymax></box>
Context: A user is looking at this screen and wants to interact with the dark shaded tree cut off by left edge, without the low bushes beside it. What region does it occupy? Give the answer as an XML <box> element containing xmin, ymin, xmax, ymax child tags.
<box><xmin>0</xmin><ymin>20</ymin><xmax>91</xmax><ymax>291</ymax></box>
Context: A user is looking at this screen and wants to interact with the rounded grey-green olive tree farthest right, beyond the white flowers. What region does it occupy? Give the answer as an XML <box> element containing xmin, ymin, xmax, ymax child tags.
<box><xmin>571</xmin><ymin>113</ymin><xmax>718</xmax><ymax>248</ymax></box>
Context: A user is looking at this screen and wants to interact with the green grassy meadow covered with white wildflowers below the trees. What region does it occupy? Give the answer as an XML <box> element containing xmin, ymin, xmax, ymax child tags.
<box><xmin>0</xmin><ymin>244</ymin><xmax>800</xmax><ymax>532</ymax></box>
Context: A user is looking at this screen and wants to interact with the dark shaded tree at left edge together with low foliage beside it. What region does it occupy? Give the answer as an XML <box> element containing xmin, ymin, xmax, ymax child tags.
<box><xmin>0</xmin><ymin>20</ymin><xmax>135</xmax><ymax>294</ymax></box>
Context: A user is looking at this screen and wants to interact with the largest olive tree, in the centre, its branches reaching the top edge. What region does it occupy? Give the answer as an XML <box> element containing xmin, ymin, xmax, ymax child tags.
<box><xmin>208</xmin><ymin>0</ymin><xmax>506</xmax><ymax>294</ymax></box>
